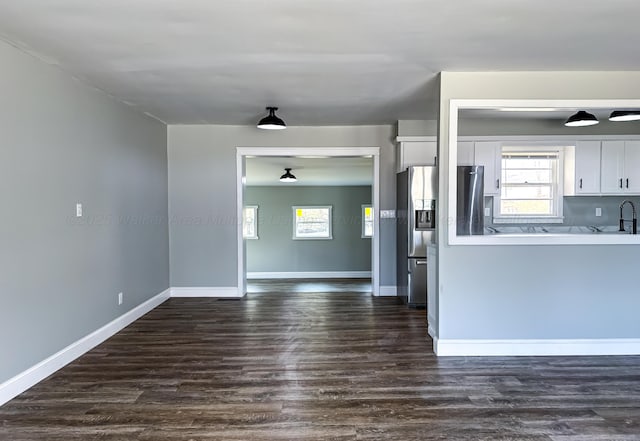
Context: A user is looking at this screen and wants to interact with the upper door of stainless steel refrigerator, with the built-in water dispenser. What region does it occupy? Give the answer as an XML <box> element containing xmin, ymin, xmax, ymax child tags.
<box><xmin>406</xmin><ymin>167</ymin><xmax>438</xmax><ymax>258</ymax></box>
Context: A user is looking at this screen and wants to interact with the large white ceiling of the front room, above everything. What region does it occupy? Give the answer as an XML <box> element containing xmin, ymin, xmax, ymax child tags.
<box><xmin>0</xmin><ymin>0</ymin><xmax>640</xmax><ymax>125</ymax></box>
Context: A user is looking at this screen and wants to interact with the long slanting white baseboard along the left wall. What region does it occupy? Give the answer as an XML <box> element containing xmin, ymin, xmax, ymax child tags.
<box><xmin>0</xmin><ymin>289</ymin><xmax>169</xmax><ymax>406</ymax></box>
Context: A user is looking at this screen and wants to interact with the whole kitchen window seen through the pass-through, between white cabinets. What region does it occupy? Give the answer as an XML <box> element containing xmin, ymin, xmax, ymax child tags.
<box><xmin>495</xmin><ymin>147</ymin><xmax>563</xmax><ymax>222</ymax></box>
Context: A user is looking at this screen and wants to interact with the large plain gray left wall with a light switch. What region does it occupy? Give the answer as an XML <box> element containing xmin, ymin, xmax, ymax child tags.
<box><xmin>0</xmin><ymin>39</ymin><xmax>169</xmax><ymax>383</ymax></box>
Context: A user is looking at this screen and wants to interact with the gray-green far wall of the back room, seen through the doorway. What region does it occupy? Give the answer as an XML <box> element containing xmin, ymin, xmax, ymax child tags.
<box><xmin>245</xmin><ymin>186</ymin><xmax>371</xmax><ymax>272</ymax></box>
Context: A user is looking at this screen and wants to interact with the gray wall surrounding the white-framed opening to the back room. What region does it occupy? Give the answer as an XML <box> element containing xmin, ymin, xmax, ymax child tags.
<box><xmin>168</xmin><ymin>125</ymin><xmax>396</xmax><ymax>287</ymax></box>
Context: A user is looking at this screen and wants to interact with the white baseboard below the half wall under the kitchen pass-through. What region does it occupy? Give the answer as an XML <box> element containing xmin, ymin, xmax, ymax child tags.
<box><xmin>433</xmin><ymin>338</ymin><xmax>640</xmax><ymax>357</ymax></box>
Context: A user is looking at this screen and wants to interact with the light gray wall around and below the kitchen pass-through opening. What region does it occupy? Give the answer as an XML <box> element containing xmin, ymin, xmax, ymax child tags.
<box><xmin>437</xmin><ymin>72</ymin><xmax>640</xmax><ymax>340</ymax></box>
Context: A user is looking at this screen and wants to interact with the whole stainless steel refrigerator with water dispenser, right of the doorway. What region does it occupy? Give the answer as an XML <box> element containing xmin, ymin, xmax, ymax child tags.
<box><xmin>396</xmin><ymin>166</ymin><xmax>438</xmax><ymax>308</ymax></box>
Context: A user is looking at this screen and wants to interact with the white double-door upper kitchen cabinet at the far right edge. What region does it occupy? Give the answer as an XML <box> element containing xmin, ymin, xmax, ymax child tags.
<box><xmin>600</xmin><ymin>141</ymin><xmax>640</xmax><ymax>194</ymax></box>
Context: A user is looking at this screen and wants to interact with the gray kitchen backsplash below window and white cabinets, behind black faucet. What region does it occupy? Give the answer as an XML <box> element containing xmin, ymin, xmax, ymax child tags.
<box><xmin>484</xmin><ymin>196</ymin><xmax>640</xmax><ymax>226</ymax></box>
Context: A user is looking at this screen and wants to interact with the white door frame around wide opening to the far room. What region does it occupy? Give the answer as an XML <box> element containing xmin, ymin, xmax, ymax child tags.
<box><xmin>236</xmin><ymin>147</ymin><xmax>380</xmax><ymax>297</ymax></box>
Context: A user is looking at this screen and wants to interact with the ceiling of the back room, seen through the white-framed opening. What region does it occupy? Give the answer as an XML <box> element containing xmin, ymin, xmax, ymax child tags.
<box><xmin>246</xmin><ymin>157</ymin><xmax>373</xmax><ymax>186</ymax></box>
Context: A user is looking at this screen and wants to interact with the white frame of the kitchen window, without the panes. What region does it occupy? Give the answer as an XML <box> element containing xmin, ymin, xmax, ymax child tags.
<box><xmin>493</xmin><ymin>144</ymin><xmax>566</xmax><ymax>224</ymax></box>
